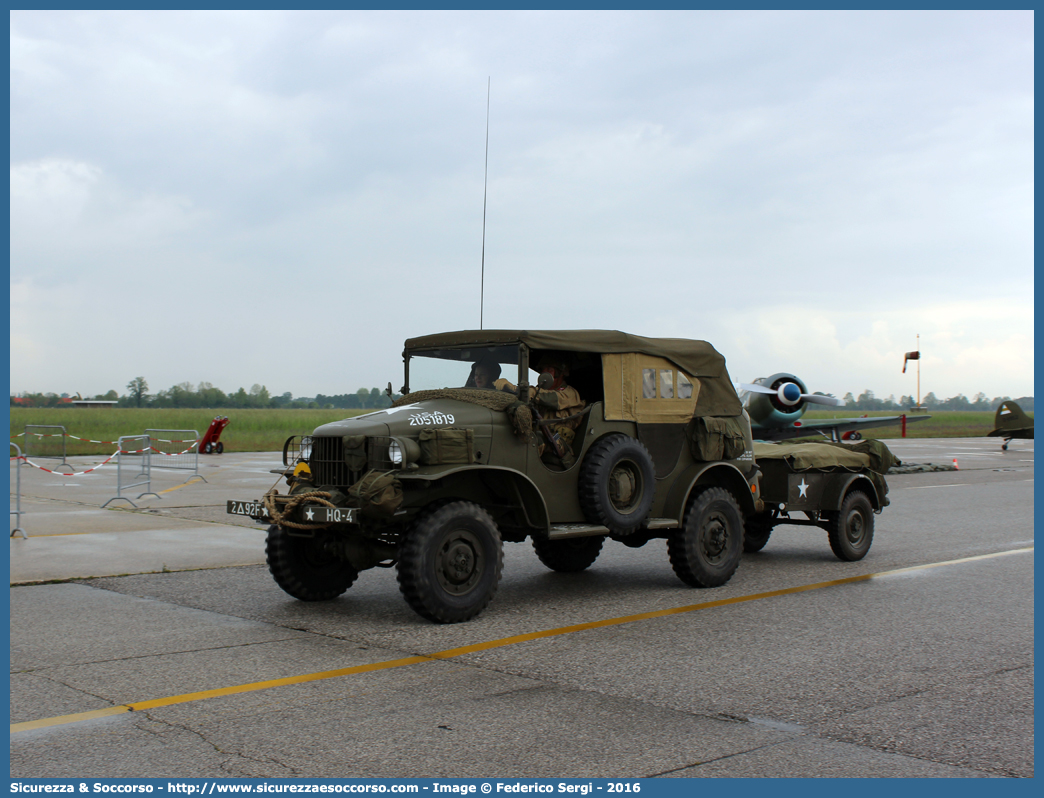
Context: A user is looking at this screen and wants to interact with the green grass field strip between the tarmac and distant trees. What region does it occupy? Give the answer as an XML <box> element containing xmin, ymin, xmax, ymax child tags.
<box><xmin>10</xmin><ymin>407</ymin><xmax>1018</xmax><ymax>455</ymax></box>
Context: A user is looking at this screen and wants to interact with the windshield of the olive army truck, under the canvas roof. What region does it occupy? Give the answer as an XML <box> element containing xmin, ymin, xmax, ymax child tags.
<box><xmin>407</xmin><ymin>345</ymin><xmax>519</xmax><ymax>393</ymax></box>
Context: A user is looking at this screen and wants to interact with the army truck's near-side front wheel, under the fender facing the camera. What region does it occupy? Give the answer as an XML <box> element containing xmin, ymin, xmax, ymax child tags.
<box><xmin>399</xmin><ymin>501</ymin><xmax>503</xmax><ymax>624</ymax></box>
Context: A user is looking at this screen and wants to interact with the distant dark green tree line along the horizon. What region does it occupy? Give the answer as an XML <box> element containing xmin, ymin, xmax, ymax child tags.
<box><xmin>10</xmin><ymin>377</ymin><xmax>1034</xmax><ymax>413</ymax></box>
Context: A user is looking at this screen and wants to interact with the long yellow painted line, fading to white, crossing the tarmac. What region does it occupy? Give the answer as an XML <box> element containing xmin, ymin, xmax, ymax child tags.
<box><xmin>10</xmin><ymin>546</ymin><xmax>1034</xmax><ymax>734</ymax></box>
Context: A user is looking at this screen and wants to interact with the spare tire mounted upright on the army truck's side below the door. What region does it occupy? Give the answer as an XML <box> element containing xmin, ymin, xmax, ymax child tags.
<box><xmin>578</xmin><ymin>432</ymin><xmax>656</xmax><ymax>535</ymax></box>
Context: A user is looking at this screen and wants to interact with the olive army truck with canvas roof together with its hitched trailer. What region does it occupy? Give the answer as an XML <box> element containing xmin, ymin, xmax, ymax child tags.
<box><xmin>228</xmin><ymin>330</ymin><xmax>891</xmax><ymax>624</ymax></box>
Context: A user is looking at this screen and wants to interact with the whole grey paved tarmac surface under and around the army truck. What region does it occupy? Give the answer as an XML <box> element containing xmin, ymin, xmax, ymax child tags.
<box><xmin>10</xmin><ymin>439</ymin><xmax>1034</xmax><ymax>778</ymax></box>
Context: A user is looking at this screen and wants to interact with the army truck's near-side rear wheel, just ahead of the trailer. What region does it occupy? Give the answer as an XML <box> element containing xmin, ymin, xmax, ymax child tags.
<box><xmin>667</xmin><ymin>488</ymin><xmax>743</xmax><ymax>587</ymax></box>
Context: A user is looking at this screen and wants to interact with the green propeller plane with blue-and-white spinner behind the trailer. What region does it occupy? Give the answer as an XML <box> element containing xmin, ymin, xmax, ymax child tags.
<box><xmin>739</xmin><ymin>373</ymin><xmax>930</xmax><ymax>441</ymax></box>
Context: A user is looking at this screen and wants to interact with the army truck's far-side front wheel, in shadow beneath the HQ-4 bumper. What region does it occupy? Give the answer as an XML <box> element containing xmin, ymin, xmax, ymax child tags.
<box><xmin>265</xmin><ymin>526</ymin><xmax>359</xmax><ymax>602</ymax></box>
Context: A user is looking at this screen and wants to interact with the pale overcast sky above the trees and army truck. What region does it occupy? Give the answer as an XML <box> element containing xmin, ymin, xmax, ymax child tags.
<box><xmin>10</xmin><ymin>11</ymin><xmax>1034</xmax><ymax>399</ymax></box>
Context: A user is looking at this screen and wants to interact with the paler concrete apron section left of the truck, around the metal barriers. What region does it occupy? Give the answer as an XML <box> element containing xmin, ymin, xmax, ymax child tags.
<box><xmin>10</xmin><ymin>452</ymin><xmax>277</xmax><ymax>584</ymax></box>
